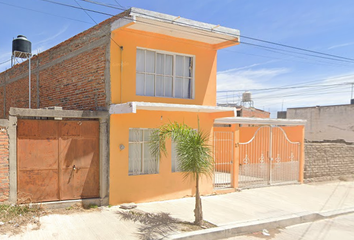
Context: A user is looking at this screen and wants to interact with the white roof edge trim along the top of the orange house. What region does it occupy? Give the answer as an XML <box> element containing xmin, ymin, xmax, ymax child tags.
<box><xmin>130</xmin><ymin>7</ymin><xmax>240</xmax><ymax>41</ymax></box>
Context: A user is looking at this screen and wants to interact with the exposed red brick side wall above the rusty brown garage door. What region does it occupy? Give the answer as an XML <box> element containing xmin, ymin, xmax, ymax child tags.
<box><xmin>0</xmin><ymin>12</ymin><xmax>127</xmax><ymax>118</ymax></box>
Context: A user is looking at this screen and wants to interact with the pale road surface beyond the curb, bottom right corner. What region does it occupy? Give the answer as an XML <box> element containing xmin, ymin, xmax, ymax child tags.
<box><xmin>224</xmin><ymin>213</ymin><xmax>354</xmax><ymax>240</ymax></box>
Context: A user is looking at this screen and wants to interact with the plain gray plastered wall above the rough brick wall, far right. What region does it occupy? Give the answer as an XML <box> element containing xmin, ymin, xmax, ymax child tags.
<box><xmin>287</xmin><ymin>104</ymin><xmax>354</xmax><ymax>142</ymax></box>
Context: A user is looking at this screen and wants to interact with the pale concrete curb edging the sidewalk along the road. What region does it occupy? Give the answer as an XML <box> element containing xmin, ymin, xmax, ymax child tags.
<box><xmin>167</xmin><ymin>208</ymin><xmax>354</xmax><ymax>240</ymax></box>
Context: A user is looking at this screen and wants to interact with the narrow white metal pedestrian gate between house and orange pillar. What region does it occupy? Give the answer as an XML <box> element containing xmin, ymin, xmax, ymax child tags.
<box><xmin>214</xmin><ymin>132</ymin><xmax>234</xmax><ymax>189</ymax></box>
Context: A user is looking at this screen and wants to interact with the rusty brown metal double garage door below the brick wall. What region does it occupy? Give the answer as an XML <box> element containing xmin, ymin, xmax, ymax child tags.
<box><xmin>17</xmin><ymin>119</ymin><xmax>100</xmax><ymax>202</ymax></box>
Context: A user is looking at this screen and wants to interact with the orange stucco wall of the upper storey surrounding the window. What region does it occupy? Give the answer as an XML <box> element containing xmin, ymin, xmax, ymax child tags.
<box><xmin>110</xmin><ymin>28</ymin><xmax>217</xmax><ymax>106</ymax></box>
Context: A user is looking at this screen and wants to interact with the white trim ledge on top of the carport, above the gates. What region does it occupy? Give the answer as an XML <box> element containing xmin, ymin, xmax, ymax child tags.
<box><xmin>214</xmin><ymin>117</ymin><xmax>307</xmax><ymax>126</ymax></box>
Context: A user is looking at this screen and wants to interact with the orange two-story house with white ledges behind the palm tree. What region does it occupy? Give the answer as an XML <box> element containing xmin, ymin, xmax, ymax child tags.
<box><xmin>109</xmin><ymin>8</ymin><xmax>239</xmax><ymax>204</ymax></box>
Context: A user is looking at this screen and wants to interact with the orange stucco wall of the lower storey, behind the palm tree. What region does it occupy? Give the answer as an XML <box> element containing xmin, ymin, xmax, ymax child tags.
<box><xmin>109</xmin><ymin>110</ymin><xmax>234</xmax><ymax>204</ymax></box>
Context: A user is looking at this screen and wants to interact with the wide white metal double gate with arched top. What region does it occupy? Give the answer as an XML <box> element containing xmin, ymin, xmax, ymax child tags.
<box><xmin>238</xmin><ymin>126</ymin><xmax>300</xmax><ymax>188</ymax></box>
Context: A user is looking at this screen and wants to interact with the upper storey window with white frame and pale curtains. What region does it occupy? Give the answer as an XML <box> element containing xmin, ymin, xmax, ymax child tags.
<box><xmin>136</xmin><ymin>49</ymin><xmax>194</xmax><ymax>99</ymax></box>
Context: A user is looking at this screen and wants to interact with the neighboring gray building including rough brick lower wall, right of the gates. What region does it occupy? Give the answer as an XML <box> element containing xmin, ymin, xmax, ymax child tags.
<box><xmin>280</xmin><ymin>102</ymin><xmax>354</xmax><ymax>181</ymax></box>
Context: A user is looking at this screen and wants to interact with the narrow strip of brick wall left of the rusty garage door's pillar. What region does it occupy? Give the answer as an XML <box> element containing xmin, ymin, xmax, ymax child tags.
<box><xmin>0</xmin><ymin>127</ymin><xmax>9</xmax><ymax>202</ymax></box>
